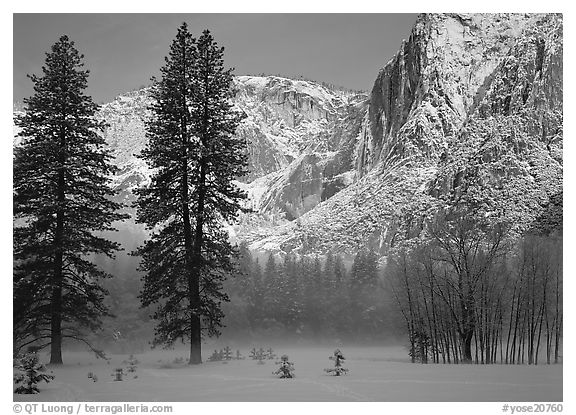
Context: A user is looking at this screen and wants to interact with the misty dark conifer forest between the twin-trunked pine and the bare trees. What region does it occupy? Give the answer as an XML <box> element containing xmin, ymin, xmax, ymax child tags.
<box><xmin>220</xmin><ymin>243</ymin><xmax>394</xmax><ymax>342</ymax></box>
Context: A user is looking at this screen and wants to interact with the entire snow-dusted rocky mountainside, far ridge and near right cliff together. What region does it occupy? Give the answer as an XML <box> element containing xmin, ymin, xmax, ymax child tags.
<box><xmin>14</xmin><ymin>14</ymin><xmax>563</xmax><ymax>254</ymax></box>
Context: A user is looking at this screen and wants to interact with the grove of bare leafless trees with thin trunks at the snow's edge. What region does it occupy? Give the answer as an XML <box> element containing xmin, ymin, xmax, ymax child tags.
<box><xmin>387</xmin><ymin>231</ymin><xmax>563</xmax><ymax>364</ymax></box>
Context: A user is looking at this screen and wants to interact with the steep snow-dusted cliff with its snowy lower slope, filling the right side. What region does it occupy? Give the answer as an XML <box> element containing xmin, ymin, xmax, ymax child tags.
<box><xmin>239</xmin><ymin>14</ymin><xmax>562</xmax><ymax>254</ymax></box>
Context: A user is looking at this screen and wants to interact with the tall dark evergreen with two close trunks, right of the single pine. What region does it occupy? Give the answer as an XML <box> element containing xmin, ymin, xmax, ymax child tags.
<box><xmin>137</xmin><ymin>23</ymin><xmax>247</xmax><ymax>364</ymax></box>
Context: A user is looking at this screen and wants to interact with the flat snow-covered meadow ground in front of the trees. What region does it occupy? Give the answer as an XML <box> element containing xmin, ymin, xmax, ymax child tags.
<box><xmin>14</xmin><ymin>345</ymin><xmax>562</xmax><ymax>402</ymax></box>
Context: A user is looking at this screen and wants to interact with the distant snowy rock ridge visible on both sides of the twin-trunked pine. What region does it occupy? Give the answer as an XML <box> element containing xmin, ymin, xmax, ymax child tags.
<box><xmin>99</xmin><ymin>76</ymin><xmax>367</xmax><ymax>220</ymax></box>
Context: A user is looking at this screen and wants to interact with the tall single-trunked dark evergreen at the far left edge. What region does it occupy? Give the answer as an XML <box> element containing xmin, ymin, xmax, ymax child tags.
<box><xmin>13</xmin><ymin>36</ymin><xmax>126</xmax><ymax>364</ymax></box>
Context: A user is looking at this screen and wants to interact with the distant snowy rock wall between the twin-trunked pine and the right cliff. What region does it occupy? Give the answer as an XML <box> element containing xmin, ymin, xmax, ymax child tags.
<box><xmin>235</xmin><ymin>76</ymin><xmax>366</xmax><ymax>200</ymax></box>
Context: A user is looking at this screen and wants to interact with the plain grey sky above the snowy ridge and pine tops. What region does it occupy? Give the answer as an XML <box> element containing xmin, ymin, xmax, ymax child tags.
<box><xmin>13</xmin><ymin>14</ymin><xmax>416</xmax><ymax>102</ymax></box>
